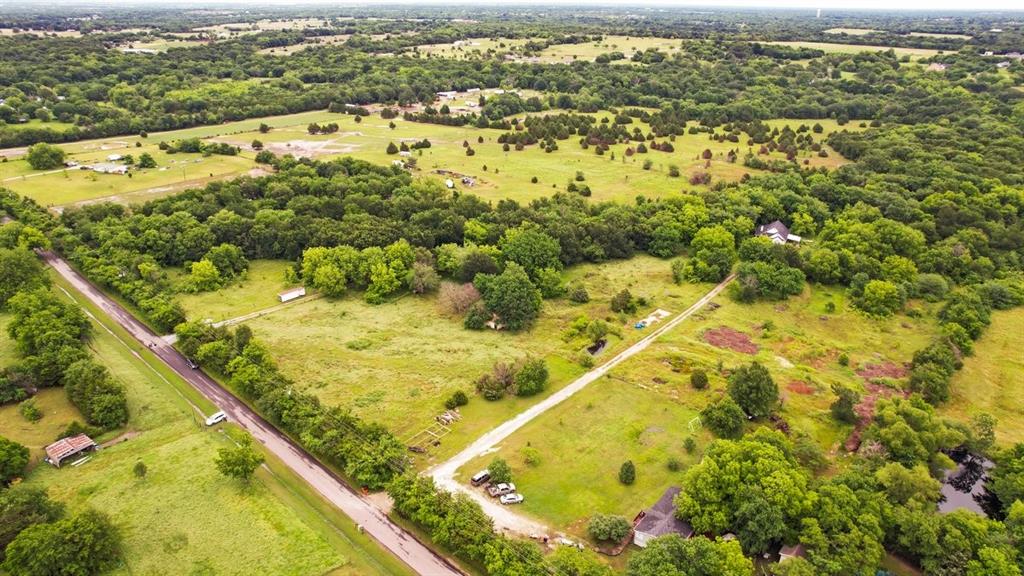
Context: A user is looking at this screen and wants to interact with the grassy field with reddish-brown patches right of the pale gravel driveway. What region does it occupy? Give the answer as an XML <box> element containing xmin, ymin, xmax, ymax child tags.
<box><xmin>459</xmin><ymin>280</ymin><xmax>935</xmax><ymax>536</ymax></box>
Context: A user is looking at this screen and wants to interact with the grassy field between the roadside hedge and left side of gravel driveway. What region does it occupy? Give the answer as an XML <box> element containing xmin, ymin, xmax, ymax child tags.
<box><xmin>185</xmin><ymin>256</ymin><xmax>707</xmax><ymax>454</ymax></box>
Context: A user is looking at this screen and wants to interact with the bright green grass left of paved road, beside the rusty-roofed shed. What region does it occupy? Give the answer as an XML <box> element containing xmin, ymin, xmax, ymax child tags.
<box><xmin>0</xmin><ymin>274</ymin><xmax>408</xmax><ymax>576</ymax></box>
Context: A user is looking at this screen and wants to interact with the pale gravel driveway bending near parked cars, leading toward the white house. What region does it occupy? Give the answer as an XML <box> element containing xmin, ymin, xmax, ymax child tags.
<box><xmin>427</xmin><ymin>274</ymin><xmax>736</xmax><ymax>536</ymax></box>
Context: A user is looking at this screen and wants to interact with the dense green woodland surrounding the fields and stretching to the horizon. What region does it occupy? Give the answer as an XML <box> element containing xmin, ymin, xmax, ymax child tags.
<box><xmin>0</xmin><ymin>7</ymin><xmax>1024</xmax><ymax>576</ymax></box>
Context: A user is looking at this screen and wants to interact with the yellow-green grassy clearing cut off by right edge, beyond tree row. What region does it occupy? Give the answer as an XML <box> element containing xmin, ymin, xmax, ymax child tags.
<box><xmin>939</xmin><ymin>307</ymin><xmax>1024</xmax><ymax>446</ymax></box>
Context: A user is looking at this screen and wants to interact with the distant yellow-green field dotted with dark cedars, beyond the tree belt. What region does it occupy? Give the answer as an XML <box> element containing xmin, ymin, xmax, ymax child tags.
<box><xmin>218</xmin><ymin>109</ymin><xmax>859</xmax><ymax>202</ymax></box>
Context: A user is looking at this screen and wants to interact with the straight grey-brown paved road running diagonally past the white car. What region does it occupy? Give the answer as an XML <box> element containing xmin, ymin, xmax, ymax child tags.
<box><xmin>41</xmin><ymin>252</ymin><xmax>463</xmax><ymax>576</ymax></box>
